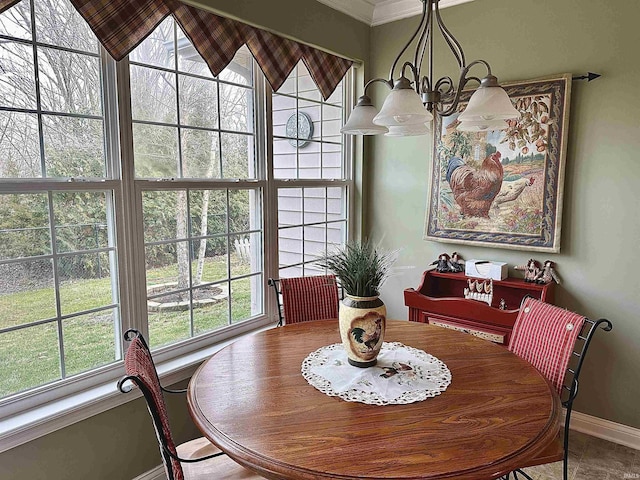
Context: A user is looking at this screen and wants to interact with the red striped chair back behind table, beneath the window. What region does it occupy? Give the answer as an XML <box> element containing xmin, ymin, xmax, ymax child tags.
<box><xmin>269</xmin><ymin>275</ymin><xmax>339</xmax><ymax>326</ymax></box>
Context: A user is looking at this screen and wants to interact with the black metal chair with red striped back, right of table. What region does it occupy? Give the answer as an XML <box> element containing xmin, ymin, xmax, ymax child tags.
<box><xmin>503</xmin><ymin>297</ymin><xmax>613</xmax><ymax>480</ymax></box>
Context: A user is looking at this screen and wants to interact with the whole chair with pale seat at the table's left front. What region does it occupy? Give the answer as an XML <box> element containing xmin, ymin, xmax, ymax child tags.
<box><xmin>118</xmin><ymin>330</ymin><xmax>263</xmax><ymax>480</ymax></box>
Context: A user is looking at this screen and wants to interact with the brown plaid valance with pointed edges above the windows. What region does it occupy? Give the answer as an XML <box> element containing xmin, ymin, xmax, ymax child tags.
<box><xmin>0</xmin><ymin>0</ymin><xmax>353</xmax><ymax>100</ymax></box>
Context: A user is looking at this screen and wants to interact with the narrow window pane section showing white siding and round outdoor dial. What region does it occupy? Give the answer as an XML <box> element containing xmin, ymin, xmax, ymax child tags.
<box><xmin>272</xmin><ymin>63</ymin><xmax>352</xmax><ymax>277</ymax></box>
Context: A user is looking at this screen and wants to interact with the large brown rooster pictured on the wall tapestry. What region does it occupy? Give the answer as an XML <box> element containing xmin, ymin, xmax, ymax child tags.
<box><xmin>446</xmin><ymin>152</ymin><xmax>504</xmax><ymax>218</ymax></box>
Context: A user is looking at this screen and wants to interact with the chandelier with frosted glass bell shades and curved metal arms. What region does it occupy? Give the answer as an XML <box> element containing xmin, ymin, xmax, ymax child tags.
<box><xmin>340</xmin><ymin>0</ymin><xmax>520</xmax><ymax>136</ymax></box>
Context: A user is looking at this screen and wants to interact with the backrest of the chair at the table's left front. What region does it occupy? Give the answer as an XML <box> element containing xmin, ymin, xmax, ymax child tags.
<box><xmin>118</xmin><ymin>330</ymin><xmax>184</xmax><ymax>480</ymax></box>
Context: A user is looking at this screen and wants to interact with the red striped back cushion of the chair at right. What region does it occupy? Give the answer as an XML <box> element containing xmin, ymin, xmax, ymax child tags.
<box><xmin>509</xmin><ymin>297</ymin><xmax>585</xmax><ymax>394</ymax></box>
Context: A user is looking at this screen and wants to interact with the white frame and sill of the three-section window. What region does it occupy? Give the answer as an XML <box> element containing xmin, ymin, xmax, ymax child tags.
<box><xmin>0</xmin><ymin>6</ymin><xmax>355</xmax><ymax>453</ymax></box>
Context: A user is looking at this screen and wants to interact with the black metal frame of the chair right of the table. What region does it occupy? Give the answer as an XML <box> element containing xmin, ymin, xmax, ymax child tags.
<box><xmin>502</xmin><ymin>295</ymin><xmax>613</xmax><ymax>480</ymax></box>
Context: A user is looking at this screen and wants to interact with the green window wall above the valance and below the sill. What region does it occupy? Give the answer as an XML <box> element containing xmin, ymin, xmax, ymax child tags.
<box><xmin>0</xmin><ymin>0</ymin><xmax>370</xmax><ymax>480</ymax></box>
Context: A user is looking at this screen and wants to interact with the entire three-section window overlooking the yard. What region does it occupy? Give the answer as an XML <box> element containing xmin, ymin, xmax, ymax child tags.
<box><xmin>0</xmin><ymin>0</ymin><xmax>352</xmax><ymax>405</ymax></box>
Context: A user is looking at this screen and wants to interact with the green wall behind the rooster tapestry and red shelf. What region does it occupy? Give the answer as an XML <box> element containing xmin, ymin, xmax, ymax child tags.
<box><xmin>370</xmin><ymin>0</ymin><xmax>640</xmax><ymax>428</ymax></box>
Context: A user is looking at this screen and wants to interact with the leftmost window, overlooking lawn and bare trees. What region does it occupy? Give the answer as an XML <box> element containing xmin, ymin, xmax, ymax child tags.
<box><xmin>0</xmin><ymin>1</ymin><xmax>121</xmax><ymax>398</ymax></box>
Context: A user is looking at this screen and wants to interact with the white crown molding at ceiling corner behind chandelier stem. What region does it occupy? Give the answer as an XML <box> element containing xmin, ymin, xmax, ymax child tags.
<box><xmin>317</xmin><ymin>0</ymin><xmax>474</xmax><ymax>27</ymax></box>
